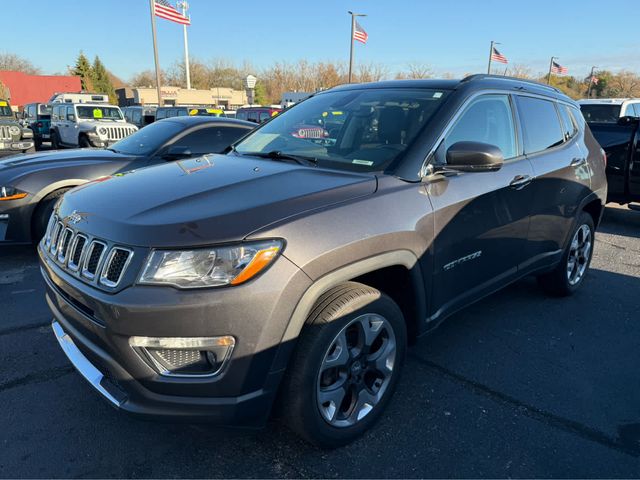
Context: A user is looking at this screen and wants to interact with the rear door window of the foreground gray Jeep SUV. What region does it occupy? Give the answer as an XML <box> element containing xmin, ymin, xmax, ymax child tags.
<box><xmin>517</xmin><ymin>95</ymin><xmax>564</xmax><ymax>154</ymax></box>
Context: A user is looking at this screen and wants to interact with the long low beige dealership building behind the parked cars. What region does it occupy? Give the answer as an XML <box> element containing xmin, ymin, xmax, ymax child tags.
<box><xmin>116</xmin><ymin>87</ymin><xmax>247</xmax><ymax>110</ymax></box>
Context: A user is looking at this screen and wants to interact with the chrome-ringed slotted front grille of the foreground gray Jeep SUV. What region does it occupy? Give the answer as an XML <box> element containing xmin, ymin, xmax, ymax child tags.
<box><xmin>41</xmin><ymin>214</ymin><xmax>133</xmax><ymax>289</ymax></box>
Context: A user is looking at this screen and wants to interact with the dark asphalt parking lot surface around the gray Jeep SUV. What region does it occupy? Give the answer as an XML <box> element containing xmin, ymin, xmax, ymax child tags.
<box><xmin>0</xmin><ymin>207</ymin><xmax>640</xmax><ymax>478</ymax></box>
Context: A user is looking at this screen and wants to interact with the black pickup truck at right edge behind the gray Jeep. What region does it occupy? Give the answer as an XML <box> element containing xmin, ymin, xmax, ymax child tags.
<box><xmin>589</xmin><ymin>117</ymin><xmax>640</xmax><ymax>208</ymax></box>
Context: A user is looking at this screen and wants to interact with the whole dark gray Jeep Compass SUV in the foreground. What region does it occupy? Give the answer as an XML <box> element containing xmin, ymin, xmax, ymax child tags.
<box><xmin>39</xmin><ymin>75</ymin><xmax>607</xmax><ymax>447</ymax></box>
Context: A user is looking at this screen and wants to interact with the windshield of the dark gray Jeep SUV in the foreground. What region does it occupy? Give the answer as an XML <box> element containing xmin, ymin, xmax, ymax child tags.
<box><xmin>235</xmin><ymin>88</ymin><xmax>447</xmax><ymax>171</ymax></box>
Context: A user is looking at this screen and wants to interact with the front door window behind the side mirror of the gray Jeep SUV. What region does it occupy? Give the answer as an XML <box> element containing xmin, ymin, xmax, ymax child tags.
<box><xmin>437</xmin><ymin>95</ymin><xmax>517</xmax><ymax>163</ymax></box>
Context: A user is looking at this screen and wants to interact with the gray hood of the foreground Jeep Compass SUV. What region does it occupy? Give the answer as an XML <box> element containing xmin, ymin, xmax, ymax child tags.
<box><xmin>58</xmin><ymin>155</ymin><xmax>377</xmax><ymax>247</ymax></box>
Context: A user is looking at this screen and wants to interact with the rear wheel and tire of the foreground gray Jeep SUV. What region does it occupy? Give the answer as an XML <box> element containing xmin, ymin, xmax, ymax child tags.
<box><xmin>538</xmin><ymin>212</ymin><xmax>595</xmax><ymax>296</ymax></box>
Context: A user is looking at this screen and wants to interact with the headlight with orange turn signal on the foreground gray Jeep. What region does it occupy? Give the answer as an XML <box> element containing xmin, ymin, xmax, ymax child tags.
<box><xmin>138</xmin><ymin>240</ymin><xmax>283</xmax><ymax>288</ymax></box>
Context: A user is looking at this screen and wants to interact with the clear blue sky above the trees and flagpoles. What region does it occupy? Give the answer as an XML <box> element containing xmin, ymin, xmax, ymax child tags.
<box><xmin>0</xmin><ymin>0</ymin><xmax>640</xmax><ymax>80</ymax></box>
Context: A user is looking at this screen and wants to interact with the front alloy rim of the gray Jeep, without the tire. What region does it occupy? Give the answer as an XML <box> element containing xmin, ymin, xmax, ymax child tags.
<box><xmin>316</xmin><ymin>313</ymin><xmax>396</xmax><ymax>427</ymax></box>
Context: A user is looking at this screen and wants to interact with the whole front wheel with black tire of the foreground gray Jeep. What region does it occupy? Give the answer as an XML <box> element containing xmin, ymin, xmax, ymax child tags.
<box><xmin>278</xmin><ymin>282</ymin><xmax>407</xmax><ymax>448</ymax></box>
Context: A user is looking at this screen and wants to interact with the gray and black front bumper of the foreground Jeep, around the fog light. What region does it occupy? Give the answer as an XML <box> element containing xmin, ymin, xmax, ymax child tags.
<box><xmin>39</xmin><ymin>244</ymin><xmax>307</xmax><ymax>427</ymax></box>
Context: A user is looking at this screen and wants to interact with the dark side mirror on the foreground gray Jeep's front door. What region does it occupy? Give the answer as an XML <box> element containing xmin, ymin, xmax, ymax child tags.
<box><xmin>443</xmin><ymin>142</ymin><xmax>504</xmax><ymax>172</ymax></box>
